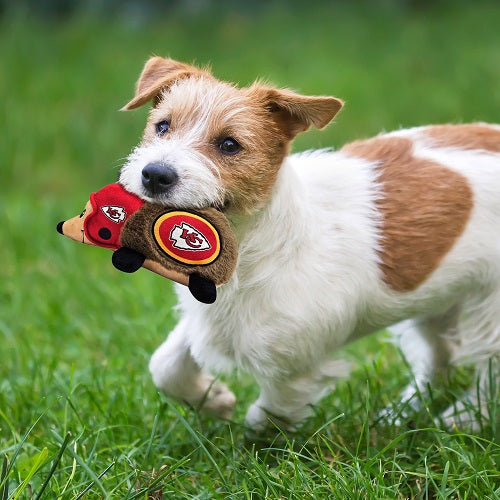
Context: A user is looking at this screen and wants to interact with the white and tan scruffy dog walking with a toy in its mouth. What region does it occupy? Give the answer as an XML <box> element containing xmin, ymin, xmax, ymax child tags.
<box><xmin>120</xmin><ymin>57</ymin><xmax>500</xmax><ymax>431</ymax></box>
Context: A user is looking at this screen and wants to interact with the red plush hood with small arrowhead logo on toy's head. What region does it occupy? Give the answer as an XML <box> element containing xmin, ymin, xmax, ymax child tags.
<box><xmin>83</xmin><ymin>184</ymin><xmax>144</xmax><ymax>250</ymax></box>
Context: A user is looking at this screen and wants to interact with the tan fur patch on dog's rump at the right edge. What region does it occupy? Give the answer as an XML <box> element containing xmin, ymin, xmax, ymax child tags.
<box><xmin>424</xmin><ymin>124</ymin><xmax>500</xmax><ymax>153</ymax></box>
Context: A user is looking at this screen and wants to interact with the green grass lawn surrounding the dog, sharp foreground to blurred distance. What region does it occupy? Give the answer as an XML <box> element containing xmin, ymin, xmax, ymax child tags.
<box><xmin>0</xmin><ymin>2</ymin><xmax>500</xmax><ymax>500</ymax></box>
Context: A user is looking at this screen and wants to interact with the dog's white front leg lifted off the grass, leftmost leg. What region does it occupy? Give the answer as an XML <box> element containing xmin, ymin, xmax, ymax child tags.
<box><xmin>149</xmin><ymin>319</ymin><xmax>236</xmax><ymax>418</ymax></box>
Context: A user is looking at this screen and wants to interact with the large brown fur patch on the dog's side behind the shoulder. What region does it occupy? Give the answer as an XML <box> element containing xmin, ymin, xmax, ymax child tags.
<box><xmin>342</xmin><ymin>137</ymin><xmax>473</xmax><ymax>292</ymax></box>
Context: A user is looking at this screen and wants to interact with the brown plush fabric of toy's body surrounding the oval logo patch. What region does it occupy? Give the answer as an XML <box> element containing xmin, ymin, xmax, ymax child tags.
<box><xmin>120</xmin><ymin>203</ymin><xmax>238</xmax><ymax>285</ymax></box>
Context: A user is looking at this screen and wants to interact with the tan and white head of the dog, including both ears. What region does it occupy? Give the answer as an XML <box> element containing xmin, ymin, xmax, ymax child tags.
<box><xmin>120</xmin><ymin>57</ymin><xmax>342</xmax><ymax>212</ymax></box>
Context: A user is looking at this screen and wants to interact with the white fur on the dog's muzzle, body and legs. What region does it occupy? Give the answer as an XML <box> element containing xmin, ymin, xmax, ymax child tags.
<box><xmin>131</xmin><ymin>124</ymin><xmax>500</xmax><ymax>429</ymax></box>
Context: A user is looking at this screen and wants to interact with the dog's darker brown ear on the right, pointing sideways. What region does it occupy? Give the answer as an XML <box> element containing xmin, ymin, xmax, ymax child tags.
<box><xmin>250</xmin><ymin>84</ymin><xmax>344</xmax><ymax>139</ymax></box>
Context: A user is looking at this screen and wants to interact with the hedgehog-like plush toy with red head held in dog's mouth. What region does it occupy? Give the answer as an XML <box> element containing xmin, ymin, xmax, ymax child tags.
<box><xmin>57</xmin><ymin>184</ymin><xmax>238</xmax><ymax>304</ymax></box>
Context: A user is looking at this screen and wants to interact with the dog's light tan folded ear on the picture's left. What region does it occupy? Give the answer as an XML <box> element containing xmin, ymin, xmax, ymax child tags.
<box><xmin>122</xmin><ymin>57</ymin><xmax>210</xmax><ymax>111</ymax></box>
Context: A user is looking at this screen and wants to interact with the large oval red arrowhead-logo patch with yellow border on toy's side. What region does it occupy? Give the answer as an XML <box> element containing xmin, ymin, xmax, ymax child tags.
<box><xmin>153</xmin><ymin>211</ymin><xmax>220</xmax><ymax>265</ymax></box>
